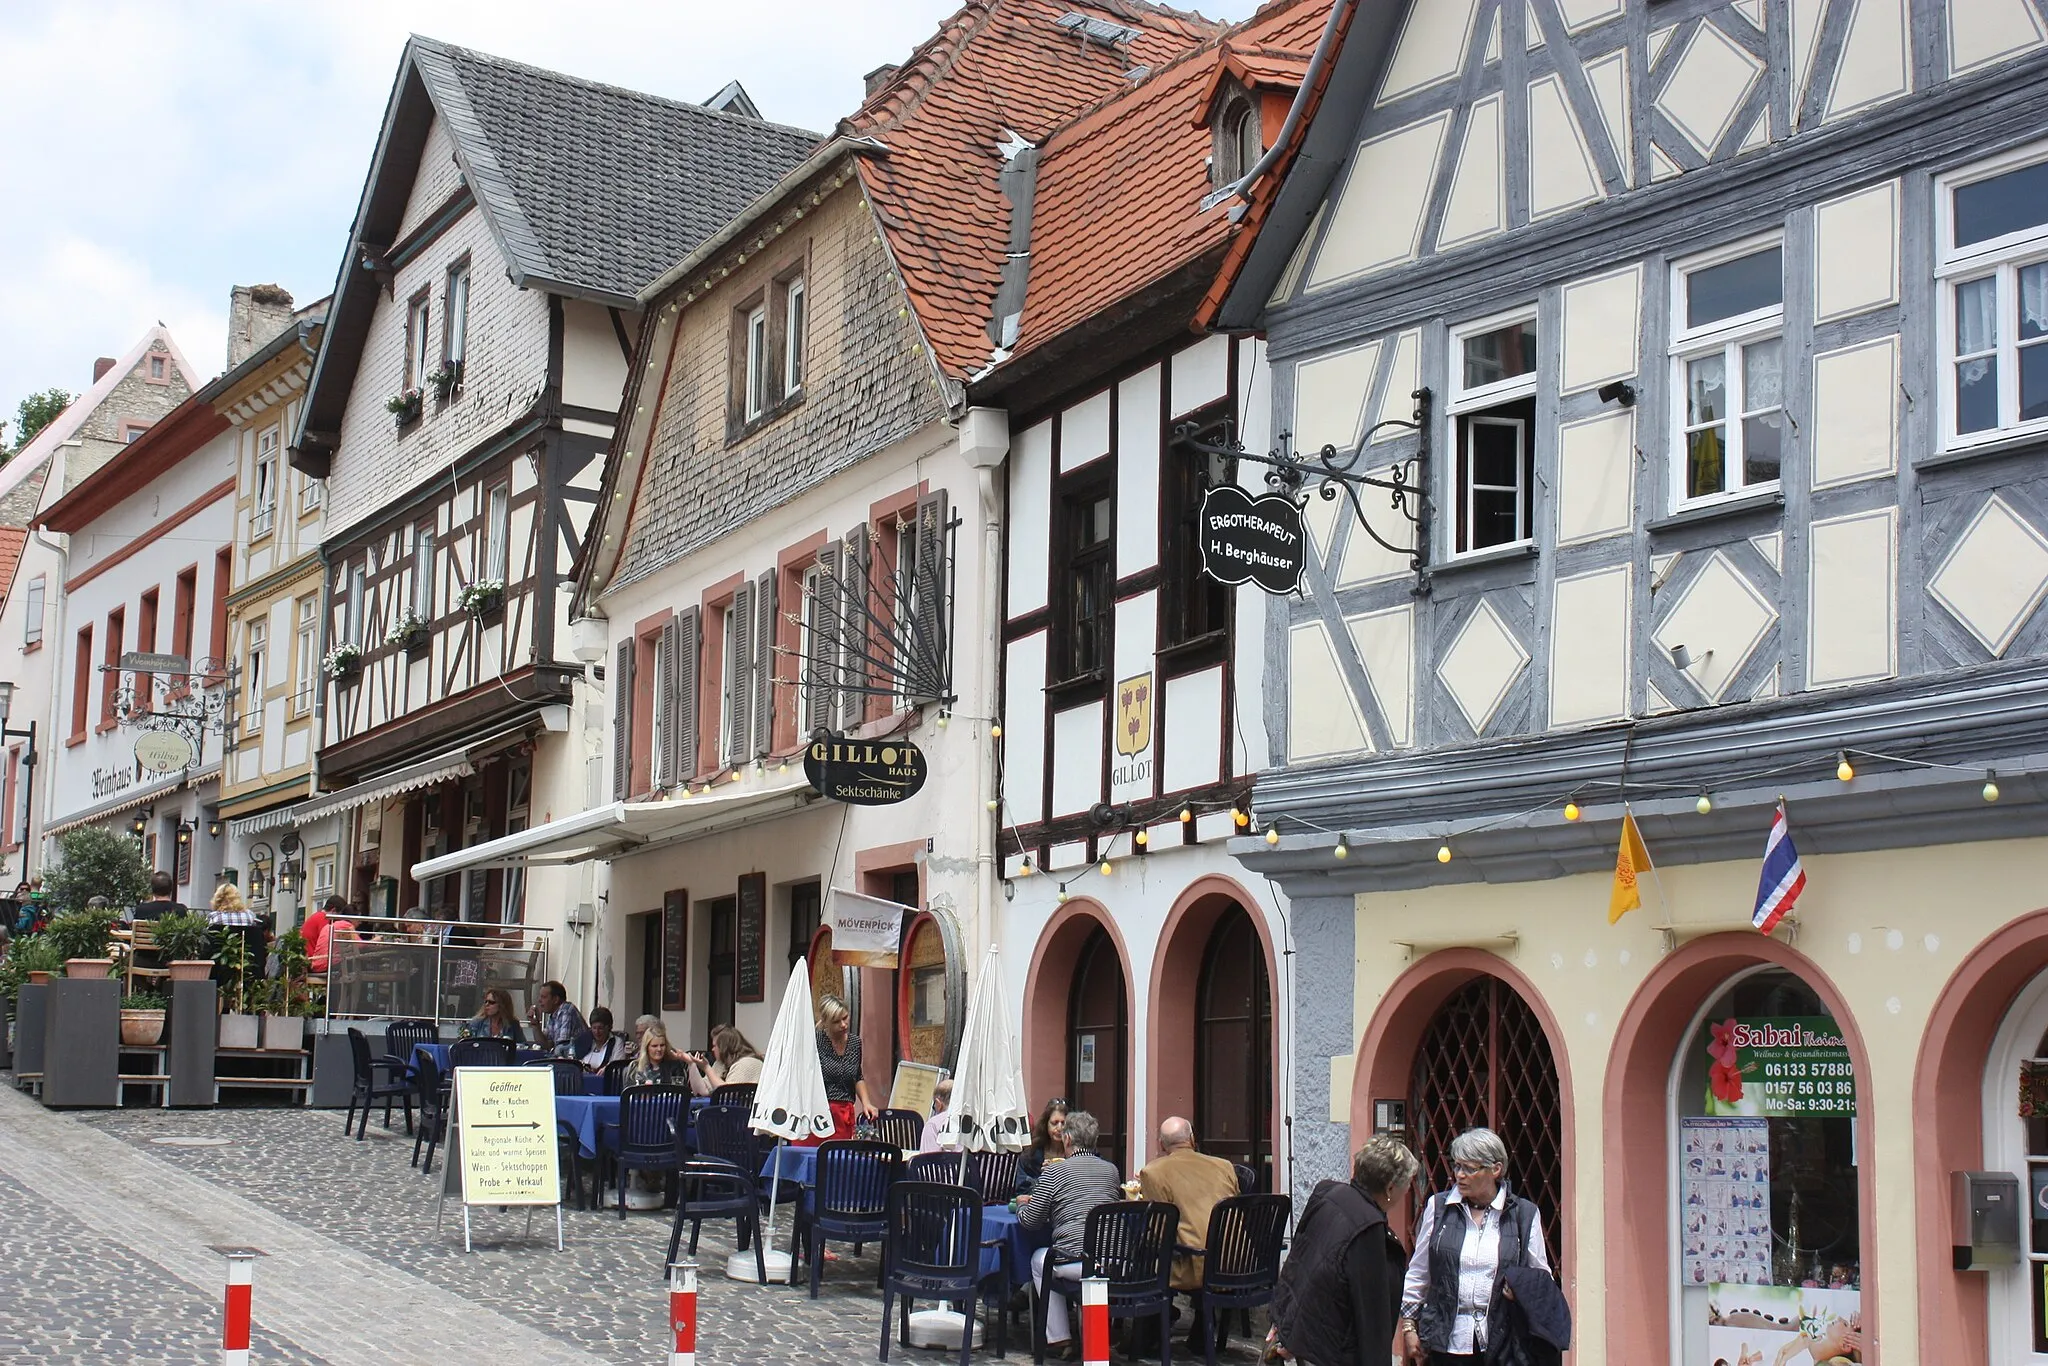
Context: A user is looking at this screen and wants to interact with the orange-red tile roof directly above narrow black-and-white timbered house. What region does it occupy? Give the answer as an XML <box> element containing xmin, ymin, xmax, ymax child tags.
<box><xmin>995</xmin><ymin>0</ymin><xmax>1329</xmax><ymax>360</ymax></box>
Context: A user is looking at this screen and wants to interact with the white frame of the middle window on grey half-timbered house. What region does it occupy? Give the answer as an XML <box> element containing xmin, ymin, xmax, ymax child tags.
<box><xmin>1669</xmin><ymin>233</ymin><xmax>1792</xmax><ymax>508</ymax></box>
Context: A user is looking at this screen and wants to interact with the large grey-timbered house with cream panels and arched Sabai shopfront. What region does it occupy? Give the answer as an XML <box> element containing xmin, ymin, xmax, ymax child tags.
<box><xmin>1210</xmin><ymin>0</ymin><xmax>2048</xmax><ymax>1366</ymax></box>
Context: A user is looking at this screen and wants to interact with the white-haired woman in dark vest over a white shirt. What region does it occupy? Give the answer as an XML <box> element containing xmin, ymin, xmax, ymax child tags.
<box><xmin>1397</xmin><ymin>1128</ymin><xmax>1550</xmax><ymax>1366</ymax></box>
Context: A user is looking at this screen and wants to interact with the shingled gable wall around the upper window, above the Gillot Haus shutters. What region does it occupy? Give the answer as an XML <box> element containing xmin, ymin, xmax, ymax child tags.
<box><xmin>610</xmin><ymin>171</ymin><xmax>946</xmax><ymax>590</ymax></box>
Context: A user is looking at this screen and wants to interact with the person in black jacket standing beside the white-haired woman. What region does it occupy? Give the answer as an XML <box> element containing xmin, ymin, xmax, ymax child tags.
<box><xmin>1274</xmin><ymin>1135</ymin><xmax>1421</xmax><ymax>1366</ymax></box>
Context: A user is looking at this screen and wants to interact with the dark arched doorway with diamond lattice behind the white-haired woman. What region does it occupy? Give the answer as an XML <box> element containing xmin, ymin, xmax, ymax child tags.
<box><xmin>1409</xmin><ymin>973</ymin><xmax>1565</xmax><ymax>1266</ymax></box>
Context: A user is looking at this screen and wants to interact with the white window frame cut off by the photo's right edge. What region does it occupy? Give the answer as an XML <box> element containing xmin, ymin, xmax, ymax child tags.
<box><xmin>1933</xmin><ymin>141</ymin><xmax>2048</xmax><ymax>451</ymax></box>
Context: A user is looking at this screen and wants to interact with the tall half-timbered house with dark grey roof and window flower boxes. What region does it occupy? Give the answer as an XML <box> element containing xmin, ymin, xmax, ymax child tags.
<box><xmin>291</xmin><ymin>37</ymin><xmax>815</xmax><ymax>999</ymax></box>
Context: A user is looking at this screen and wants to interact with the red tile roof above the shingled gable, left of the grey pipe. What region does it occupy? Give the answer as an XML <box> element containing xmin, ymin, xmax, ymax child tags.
<box><xmin>840</xmin><ymin>0</ymin><xmax>1223</xmax><ymax>379</ymax></box>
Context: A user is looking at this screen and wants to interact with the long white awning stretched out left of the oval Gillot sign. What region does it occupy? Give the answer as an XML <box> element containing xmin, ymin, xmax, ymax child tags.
<box><xmin>412</xmin><ymin>776</ymin><xmax>817</xmax><ymax>883</ymax></box>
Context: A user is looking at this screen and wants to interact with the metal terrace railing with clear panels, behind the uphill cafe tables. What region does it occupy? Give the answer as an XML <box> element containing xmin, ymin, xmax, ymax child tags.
<box><xmin>328</xmin><ymin>920</ymin><xmax>553</xmax><ymax>1022</ymax></box>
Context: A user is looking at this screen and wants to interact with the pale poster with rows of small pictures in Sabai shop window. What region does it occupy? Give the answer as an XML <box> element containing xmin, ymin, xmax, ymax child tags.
<box><xmin>1677</xmin><ymin>1114</ymin><xmax>1772</xmax><ymax>1286</ymax></box>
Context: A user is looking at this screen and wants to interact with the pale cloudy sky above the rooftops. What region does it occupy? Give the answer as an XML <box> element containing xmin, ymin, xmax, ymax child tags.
<box><xmin>0</xmin><ymin>0</ymin><xmax>1257</xmax><ymax>422</ymax></box>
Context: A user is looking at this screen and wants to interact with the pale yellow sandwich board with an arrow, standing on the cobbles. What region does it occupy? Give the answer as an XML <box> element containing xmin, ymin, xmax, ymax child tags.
<box><xmin>451</xmin><ymin>1067</ymin><xmax>561</xmax><ymax>1251</ymax></box>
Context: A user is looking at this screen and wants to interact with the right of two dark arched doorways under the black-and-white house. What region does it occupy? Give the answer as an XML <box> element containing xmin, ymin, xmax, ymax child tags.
<box><xmin>1194</xmin><ymin>901</ymin><xmax>1274</xmax><ymax>1190</ymax></box>
